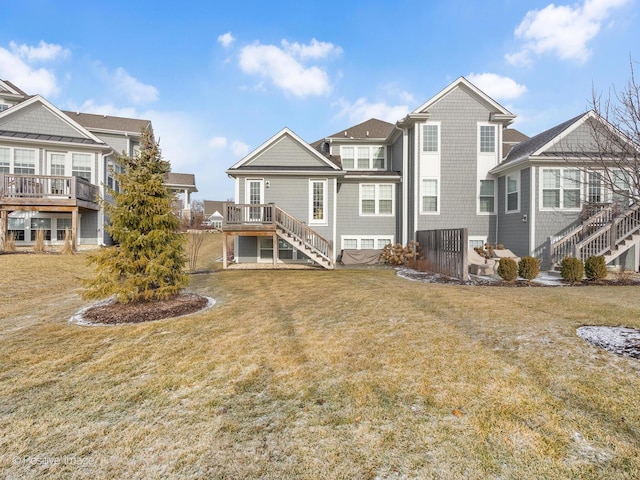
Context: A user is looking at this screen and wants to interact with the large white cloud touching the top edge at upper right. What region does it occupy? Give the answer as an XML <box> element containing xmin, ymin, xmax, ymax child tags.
<box><xmin>505</xmin><ymin>0</ymin><xmax>629</xmax><ymax>65</ymax></box>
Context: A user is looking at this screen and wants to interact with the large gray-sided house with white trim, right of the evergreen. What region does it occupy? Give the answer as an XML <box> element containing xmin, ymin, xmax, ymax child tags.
<box><xmin>223</xmin><ymin>77</ymin><xmax>640</xmax><ymax>270</ymax></box>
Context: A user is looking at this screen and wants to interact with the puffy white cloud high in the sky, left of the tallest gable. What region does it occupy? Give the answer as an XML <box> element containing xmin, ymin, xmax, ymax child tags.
<box><xmin>240</xmin><ymin>39</ymin><xmax>341</xmax><ymax>97</ymax></box>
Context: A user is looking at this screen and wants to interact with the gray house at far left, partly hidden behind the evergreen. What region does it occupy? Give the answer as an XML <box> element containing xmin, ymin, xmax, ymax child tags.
<box><xmin>0</xmin><ymin>80</ymin><xmax>197</xmax><ymax>248</ymax></box>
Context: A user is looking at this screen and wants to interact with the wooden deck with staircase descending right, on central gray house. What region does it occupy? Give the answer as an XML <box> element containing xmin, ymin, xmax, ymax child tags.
<box><xmin>222</xmin><ymin>203</ymin><xmax>335</xmax><ymax>270</ymax></box>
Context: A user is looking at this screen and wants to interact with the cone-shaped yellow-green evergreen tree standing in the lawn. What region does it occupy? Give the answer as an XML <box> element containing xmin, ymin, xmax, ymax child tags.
<box><xmin>84</xmin><ymin>125</ymin><xmax>188</xmax><ymax>303</ymax></box>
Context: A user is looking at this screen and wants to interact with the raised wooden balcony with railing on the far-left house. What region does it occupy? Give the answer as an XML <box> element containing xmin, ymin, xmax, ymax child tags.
<box><xmin>0</xmin><ymin>173</ymin><xmax>100</xmax><ymax>210</ymax></box>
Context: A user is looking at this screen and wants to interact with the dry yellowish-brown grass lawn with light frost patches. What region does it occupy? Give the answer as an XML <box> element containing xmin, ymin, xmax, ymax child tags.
<box><xmin>0</xmin><ymin>235</ymin><xmax>640</xmax><ymax>479</ymax></box>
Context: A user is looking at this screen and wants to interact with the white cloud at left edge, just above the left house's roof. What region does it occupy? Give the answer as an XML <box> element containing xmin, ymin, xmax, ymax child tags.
<box><xmin>0</xmin><ymin>47</ymin><xmax>59</xmax><ymax>97</ymax></box>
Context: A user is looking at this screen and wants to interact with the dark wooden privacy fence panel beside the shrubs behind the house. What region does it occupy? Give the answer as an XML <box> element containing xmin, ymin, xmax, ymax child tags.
<box><xmin>416</xmin><ymin>228</ymin><xmax>469</xmax><ymax>282</ymax></box>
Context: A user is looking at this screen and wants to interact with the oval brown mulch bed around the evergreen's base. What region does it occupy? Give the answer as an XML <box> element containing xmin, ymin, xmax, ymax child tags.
<box><xmin>82</xmin><ymin>294</ymin><xmax>209</xmax><ymax>325</ymax></box>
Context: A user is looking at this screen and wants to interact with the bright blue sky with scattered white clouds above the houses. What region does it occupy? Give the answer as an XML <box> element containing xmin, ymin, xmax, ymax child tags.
<box><xmin>0</xmin><ymin>0</ymin><xmax>640</xmax><ymax>200</ymax></box>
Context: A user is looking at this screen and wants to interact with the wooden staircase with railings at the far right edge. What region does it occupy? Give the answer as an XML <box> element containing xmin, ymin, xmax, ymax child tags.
<box><xmin>550</xmin><ymin>203</ymin><xmax>640</xmax><ymax>267</ymax></box>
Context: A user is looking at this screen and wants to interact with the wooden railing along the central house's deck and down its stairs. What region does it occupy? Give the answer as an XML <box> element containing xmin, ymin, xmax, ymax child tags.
<box><xmin>222</xmin><ymin>203</ymin><xmax>333</xmax><ymax>262</ymax></box>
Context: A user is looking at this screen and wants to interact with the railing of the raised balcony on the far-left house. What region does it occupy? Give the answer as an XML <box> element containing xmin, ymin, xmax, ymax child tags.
<box><xmin>0</xmin><ymin>173</ymin><xmax>99</xmax><ymax>203</ymax></box>
